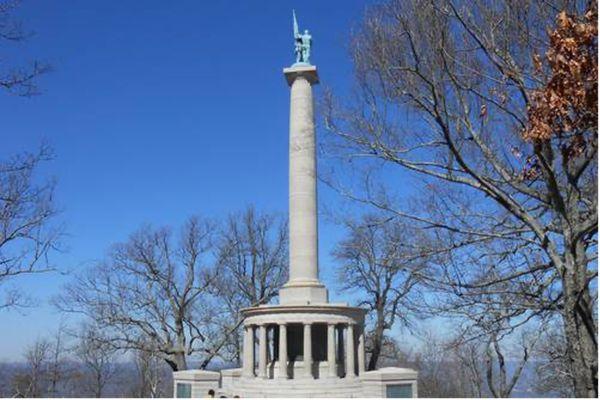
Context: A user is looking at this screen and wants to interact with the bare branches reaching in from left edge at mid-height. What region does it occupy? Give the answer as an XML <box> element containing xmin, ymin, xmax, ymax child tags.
<box><xmin>0</xmin><ymin>146</ymin><xmax>61</xmax><ymax>310</ymax></box>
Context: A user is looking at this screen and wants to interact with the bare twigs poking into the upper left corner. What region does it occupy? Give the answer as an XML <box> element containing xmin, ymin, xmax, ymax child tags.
<box><xmin>0</xmin><ymin>0</ymin><xmax>50</xmax><ymax>96</ymax></box>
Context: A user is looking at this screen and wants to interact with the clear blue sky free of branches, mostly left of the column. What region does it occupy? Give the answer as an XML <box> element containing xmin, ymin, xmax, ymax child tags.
<box><xmin>0</xmin><ymin>0</ymin><xmax>376</xmax><ymax>361</ymax></box>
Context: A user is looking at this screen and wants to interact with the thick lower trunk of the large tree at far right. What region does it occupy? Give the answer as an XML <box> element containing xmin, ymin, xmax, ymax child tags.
<box><xmin>562</xmin><ymin>255</ymin><xmax>598</xmax><ymax>398</ymax></box>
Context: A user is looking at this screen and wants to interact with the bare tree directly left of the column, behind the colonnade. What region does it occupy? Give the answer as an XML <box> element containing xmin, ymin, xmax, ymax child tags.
<box><xmin>214</xmin><ymin>207</ymin><xmax>288</xmax><ymax>364</ymax></box>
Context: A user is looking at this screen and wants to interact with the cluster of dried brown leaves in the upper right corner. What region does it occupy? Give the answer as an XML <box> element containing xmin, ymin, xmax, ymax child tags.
<box><xmin>523</xmin><ymin>2</ymin><xmax>598</xmax><ymax>152</ymax></box>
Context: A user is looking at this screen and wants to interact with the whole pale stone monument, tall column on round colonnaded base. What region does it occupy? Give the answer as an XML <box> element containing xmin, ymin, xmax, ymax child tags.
<box><xmin>173</xmin><ymin>16</ymin><xmax>417</xmax><ymax>398</ymax></box>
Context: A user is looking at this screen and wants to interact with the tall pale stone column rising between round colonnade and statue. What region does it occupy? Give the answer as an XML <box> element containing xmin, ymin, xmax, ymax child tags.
<box><xmin>280</xmin><ymin>64</ymin><xmax>327</xmax><ymax>304</ymax></box>
